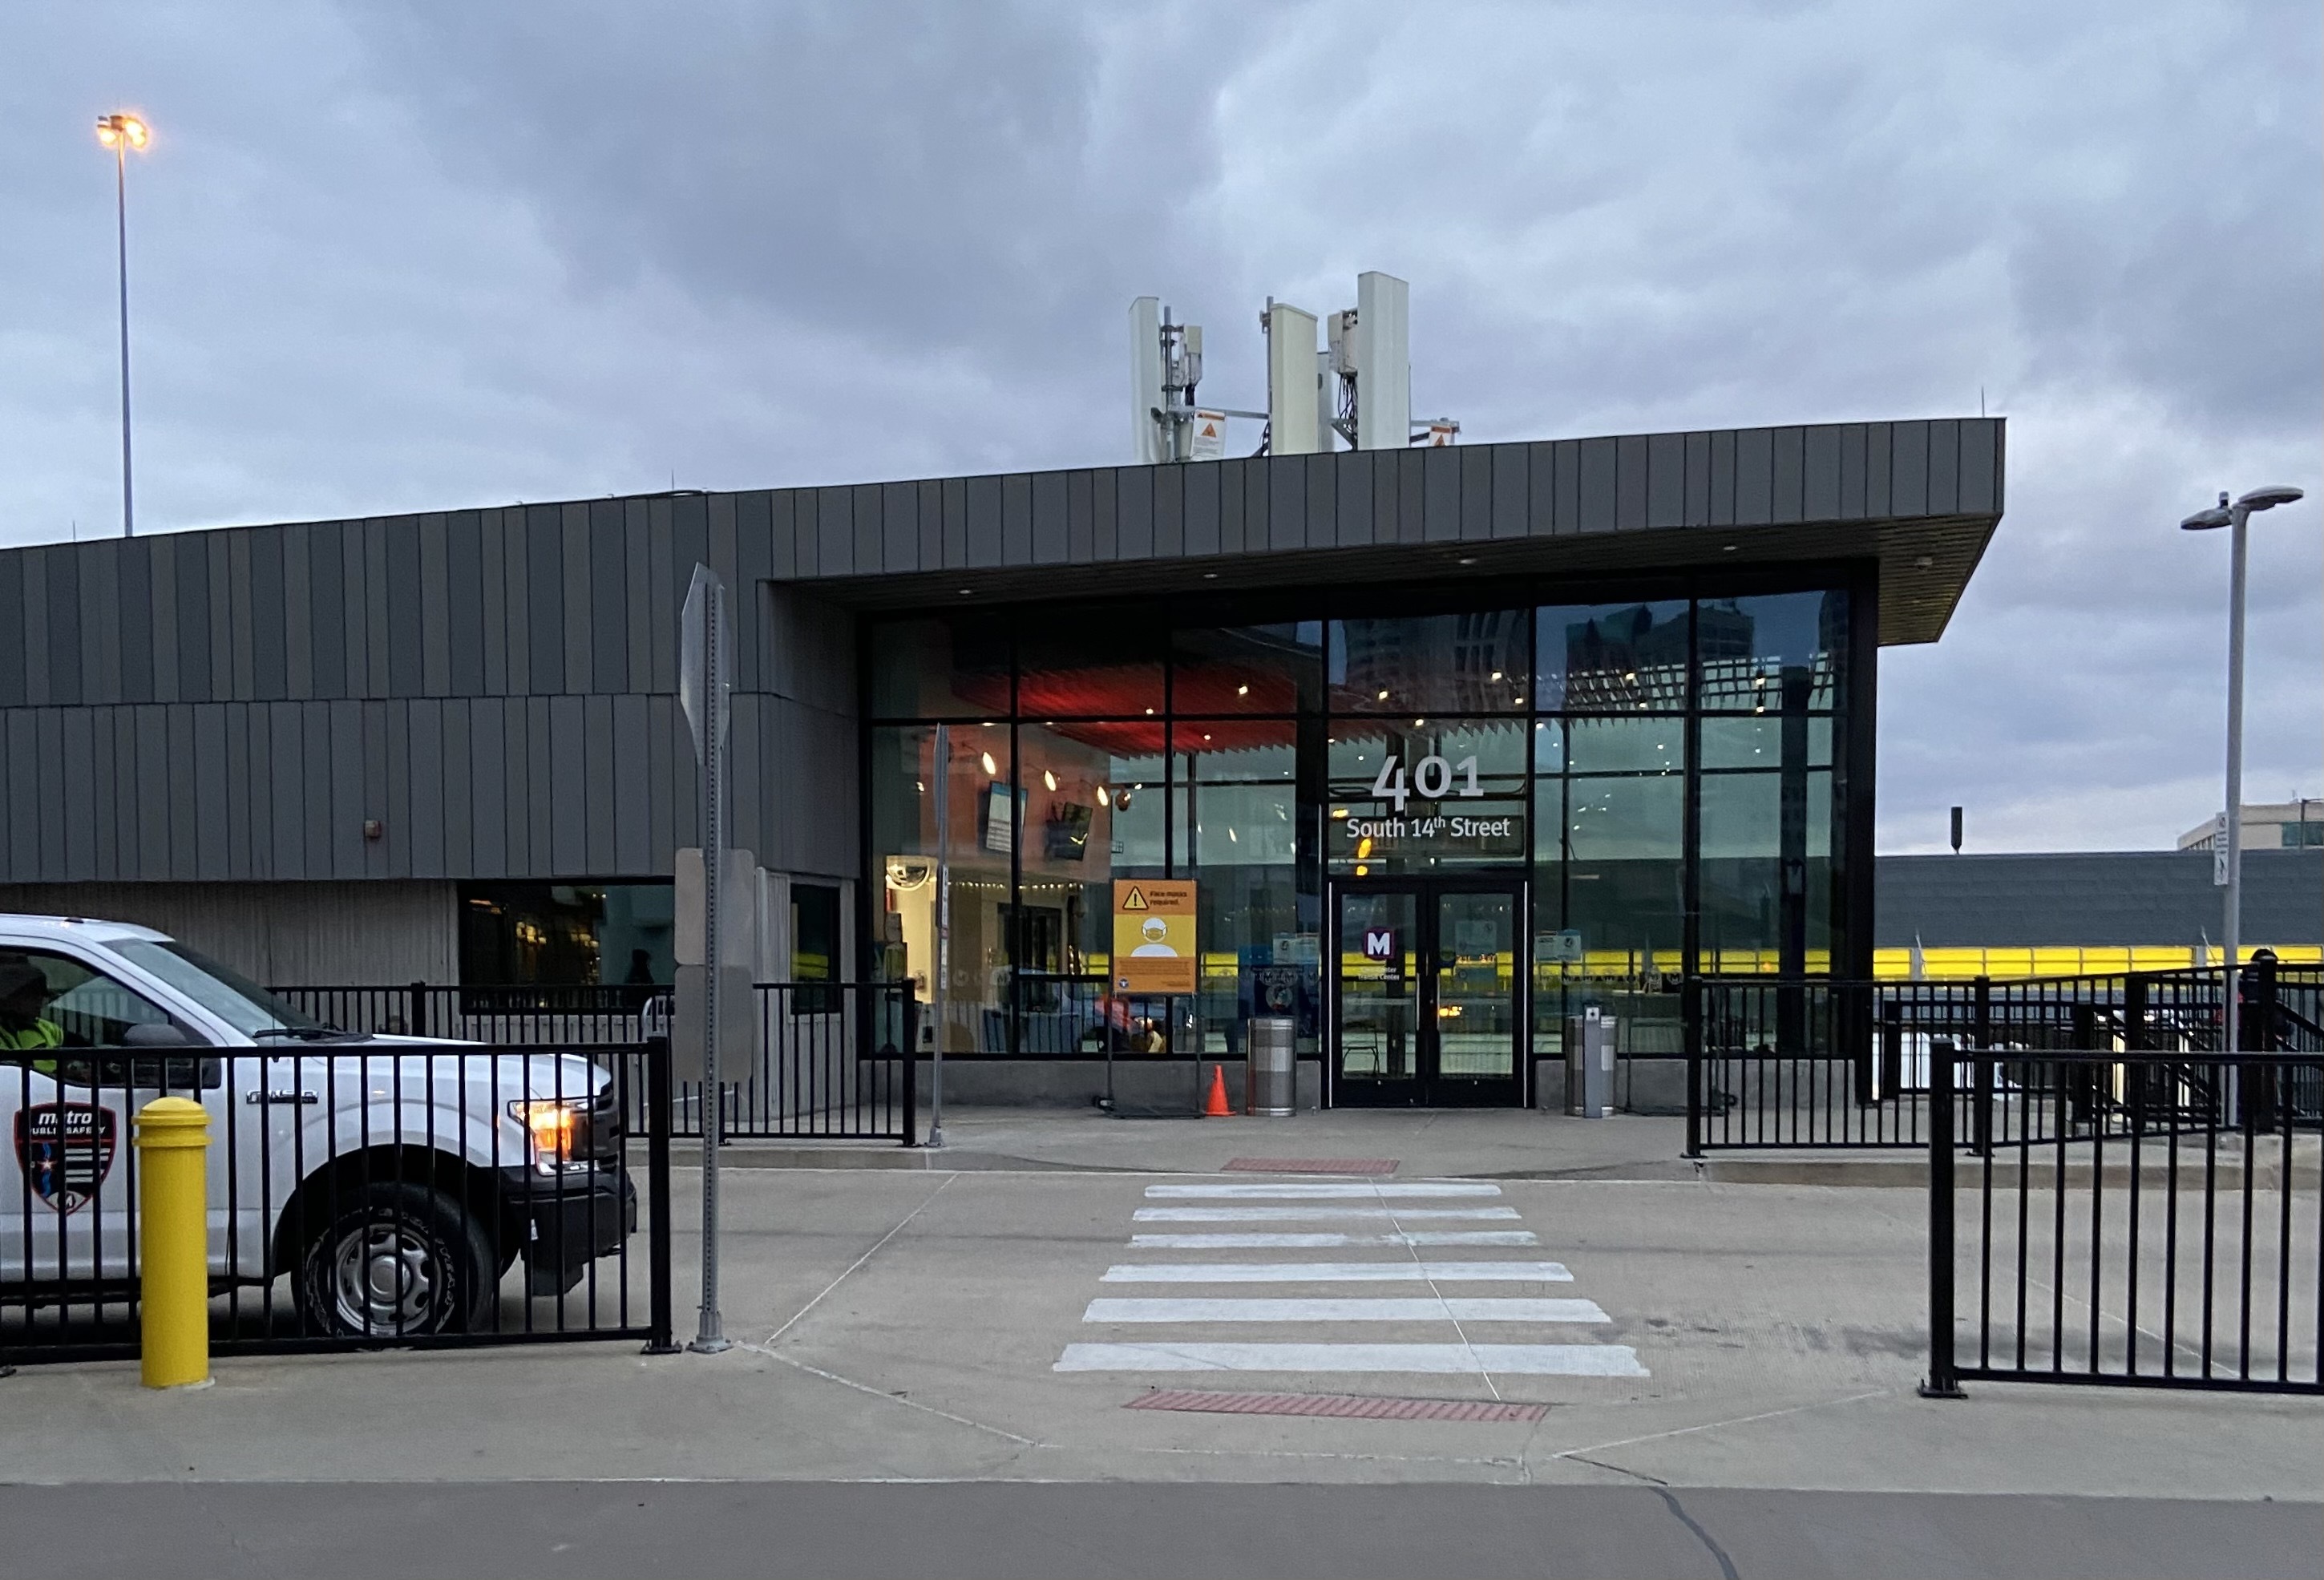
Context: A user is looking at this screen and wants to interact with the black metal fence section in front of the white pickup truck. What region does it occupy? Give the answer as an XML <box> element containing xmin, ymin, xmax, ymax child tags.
<box><xmin>0</xmin><ymin>1034</ymin><xmax>672</xmax><ymax>1364</ymax></box>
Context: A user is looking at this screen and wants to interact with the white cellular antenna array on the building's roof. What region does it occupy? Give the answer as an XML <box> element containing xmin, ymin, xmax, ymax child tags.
<box><xmin>1130</xmin><ymin>272</ymin><xmax>1460</xmax><ymax>465</ymax></box>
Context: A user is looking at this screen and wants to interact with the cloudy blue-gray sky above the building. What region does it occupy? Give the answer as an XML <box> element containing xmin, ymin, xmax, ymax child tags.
<box><xmin>0</xmin><ymin>0</ymin><xmax>2324</xmax><ymax>851</ymax></box>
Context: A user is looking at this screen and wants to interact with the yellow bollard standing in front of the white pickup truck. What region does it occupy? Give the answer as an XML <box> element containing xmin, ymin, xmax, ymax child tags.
<box><xmin>137</xmin><ymin>1097</ymin><xmax>209</xmax><ymax>1387</ymax></box>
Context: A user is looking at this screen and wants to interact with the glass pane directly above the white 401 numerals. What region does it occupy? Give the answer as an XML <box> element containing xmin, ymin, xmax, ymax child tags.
<box><xmin>1329</xmin><ymin>608</ymin><xmax>1534</xmax><ymax>716</ymax></box>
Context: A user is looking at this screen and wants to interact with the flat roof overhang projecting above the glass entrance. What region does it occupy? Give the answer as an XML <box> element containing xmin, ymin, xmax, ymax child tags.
<box><xmin>778</xmin><ymin>418</ymin><xmax>2003</xmax><ymax>646</ymax></box>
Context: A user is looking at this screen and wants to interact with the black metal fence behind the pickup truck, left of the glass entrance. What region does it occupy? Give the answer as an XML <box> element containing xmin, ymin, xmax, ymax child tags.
<box><xmin>274</xmin><ymin>983</ymin><xmax>920</xmax><ymax>1146</ymax></box>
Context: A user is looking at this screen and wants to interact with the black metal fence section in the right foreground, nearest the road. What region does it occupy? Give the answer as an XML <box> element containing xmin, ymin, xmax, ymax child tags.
<box><xmin>1922</xmin><ymin>1041</ymin><xmax>2324</xmax><ymax>1396</ymax></box>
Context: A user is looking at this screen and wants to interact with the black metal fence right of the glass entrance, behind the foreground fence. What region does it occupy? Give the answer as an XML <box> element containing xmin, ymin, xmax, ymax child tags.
<box><xmin>1683</xmin><ymin>960</ymin><xmax>2324</xmax><ymax>1157</ymax></box>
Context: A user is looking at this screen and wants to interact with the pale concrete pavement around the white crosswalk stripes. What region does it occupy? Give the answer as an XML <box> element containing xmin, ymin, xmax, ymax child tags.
<box><xmin>0</xmin><ymin>1166</ymin><xmax>2324</xmax><ymax>1501</ymax></box>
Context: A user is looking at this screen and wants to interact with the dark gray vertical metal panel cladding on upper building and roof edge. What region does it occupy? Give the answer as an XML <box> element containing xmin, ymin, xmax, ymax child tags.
<box><xmin>0</xmin><ymin>418</ymin><xmax>2003</xmax><ymax>883</ymax></box>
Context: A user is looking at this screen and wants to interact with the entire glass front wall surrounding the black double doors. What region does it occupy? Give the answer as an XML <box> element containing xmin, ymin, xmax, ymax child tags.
<box><xmin>867</xmin><ymin>590</ymin><xmax>1850</xmax><ymax>1057</ymax></box>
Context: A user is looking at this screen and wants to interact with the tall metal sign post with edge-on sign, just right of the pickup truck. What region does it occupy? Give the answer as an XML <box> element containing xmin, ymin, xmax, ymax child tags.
<box><xmin>679</xmin><ymin>564</ymin><xmax>734</xmax><ymax>1355</ymax></box>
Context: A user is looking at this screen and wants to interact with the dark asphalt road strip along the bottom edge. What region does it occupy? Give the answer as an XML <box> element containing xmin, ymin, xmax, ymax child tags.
<box><xmin>0</xmin><ymin>1482</ymin><xmax>2324</xmax><ymax>1580</ymax></box>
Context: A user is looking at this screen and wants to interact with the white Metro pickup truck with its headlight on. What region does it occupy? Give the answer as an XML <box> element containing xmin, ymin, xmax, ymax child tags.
<box><xmin>0</xmin><ymin>913</ymin><xmax>637</xmax><ymax>1339</ymax></box>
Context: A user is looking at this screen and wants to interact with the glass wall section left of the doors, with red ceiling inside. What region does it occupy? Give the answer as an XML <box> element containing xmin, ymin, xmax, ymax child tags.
<box><xmin>867</xmin><ymin>611</ymin><xmax>1323</xmax><ymax>1057</ymax></box>
